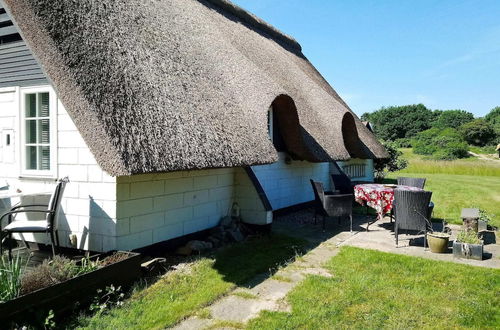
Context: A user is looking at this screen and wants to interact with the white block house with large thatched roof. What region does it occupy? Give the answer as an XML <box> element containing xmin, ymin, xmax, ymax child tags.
<box><xmin>0</xmin><ymin>0</ymin><xmax>386</xmax><ymax>251</ymax></box>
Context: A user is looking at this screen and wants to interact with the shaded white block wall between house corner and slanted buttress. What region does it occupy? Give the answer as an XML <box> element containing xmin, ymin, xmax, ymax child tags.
<box><xmin>116</xmin><ymin>168</ymin><xmax>235</xmax><ymax>250</ymax></box>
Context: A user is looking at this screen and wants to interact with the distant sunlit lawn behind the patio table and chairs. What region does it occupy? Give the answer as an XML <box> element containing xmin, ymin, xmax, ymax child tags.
<box><xmin>387</xmin><ymin>149</ymin><xmax>500</xmax><ymax>227</ymax></box>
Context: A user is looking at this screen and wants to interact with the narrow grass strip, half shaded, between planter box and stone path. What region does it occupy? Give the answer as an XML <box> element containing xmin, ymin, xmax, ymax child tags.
<box><xmin>71</xmin><ymin>235</ymin><xmax>305</xmax><ymax>329</ymax></box>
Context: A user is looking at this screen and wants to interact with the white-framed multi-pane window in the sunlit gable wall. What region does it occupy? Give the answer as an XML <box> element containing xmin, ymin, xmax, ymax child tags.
<box><xmin>20</xmin><ymin>88</ymin><xmax>56</xmax><ymax>177</ymax></box>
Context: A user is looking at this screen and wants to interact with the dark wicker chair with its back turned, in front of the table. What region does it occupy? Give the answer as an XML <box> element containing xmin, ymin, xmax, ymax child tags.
<box><xmin>394</xmin><ymin>189</ymin><xmax>432</xmax><ymax>248</ymax></box>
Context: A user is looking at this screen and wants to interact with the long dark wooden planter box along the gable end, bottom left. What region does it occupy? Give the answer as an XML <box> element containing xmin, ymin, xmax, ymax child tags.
<box><xmin>0</xmin><ymin>251</ymin><xmax>141</xmax><ymax>328</ymax></box>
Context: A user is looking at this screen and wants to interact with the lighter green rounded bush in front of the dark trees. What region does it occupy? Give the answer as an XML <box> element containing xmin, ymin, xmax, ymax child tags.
<box><xmin>412</xmin><ymin>127</ymin><xmax>469</xmax><ymax>160</ymax></box>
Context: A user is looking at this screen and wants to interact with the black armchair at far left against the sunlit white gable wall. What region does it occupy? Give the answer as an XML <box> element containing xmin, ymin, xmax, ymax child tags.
<box><xmin>0</xmin><ymin>178</ymin><xmax>69</xmax><ymax>259</ymax></box>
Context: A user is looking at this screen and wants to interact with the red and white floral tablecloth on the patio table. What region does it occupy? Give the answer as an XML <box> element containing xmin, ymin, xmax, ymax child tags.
<box><xmin>354</xmin><ymin>183</ymin><xmax>422</xmax><ymax>218</ymax></box>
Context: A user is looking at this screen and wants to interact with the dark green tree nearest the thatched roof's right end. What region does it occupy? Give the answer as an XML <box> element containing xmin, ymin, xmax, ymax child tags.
<box><xmin>361</xmin><ymin>104</ymin><xmax>434</xmax><ymax>141</ymax></box>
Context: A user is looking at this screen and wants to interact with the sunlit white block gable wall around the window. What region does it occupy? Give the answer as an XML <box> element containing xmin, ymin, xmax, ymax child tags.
<box><xmin>0</xmin><ymin>87</ymin><xmax>116</xmax><ymax>251</ymax></box>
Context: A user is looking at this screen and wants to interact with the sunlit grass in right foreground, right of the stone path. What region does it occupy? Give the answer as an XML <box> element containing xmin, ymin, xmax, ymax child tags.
<box><xmin>248</xmin><ymin>247</ymin><xmax>500</xmax><ymax>329</ymax></box>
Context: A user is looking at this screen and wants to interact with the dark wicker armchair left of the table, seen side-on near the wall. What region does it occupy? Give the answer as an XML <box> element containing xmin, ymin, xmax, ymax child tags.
<box><xmin>311</xmin><ymin>180</ymin><xmax>353</xmax><ymax>232</ymax></box>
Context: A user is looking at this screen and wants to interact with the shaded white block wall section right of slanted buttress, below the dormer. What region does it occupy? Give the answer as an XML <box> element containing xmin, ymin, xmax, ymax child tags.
<box><xmin>252</xmin><ymin>152</ymin><xmax>331</xmax><ymax>210</ymax></box>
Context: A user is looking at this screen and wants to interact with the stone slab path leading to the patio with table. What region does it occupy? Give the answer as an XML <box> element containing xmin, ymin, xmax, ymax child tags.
<box><xmin>174</xmin><ymin>211</ymin><xmax>500</xmax><ymax>329</ymax></box>
